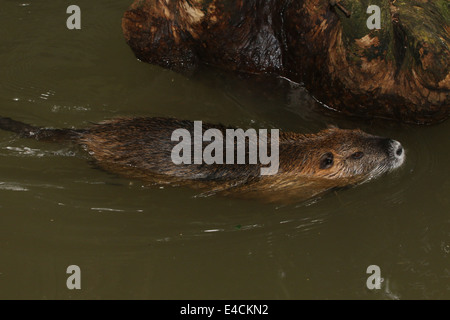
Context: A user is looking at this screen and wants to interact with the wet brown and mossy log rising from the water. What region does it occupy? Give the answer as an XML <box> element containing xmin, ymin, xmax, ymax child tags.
<box><xmin>122</xmin><ymin>0</ymin><xmax>450</xmax><ymax>124</ymax></box>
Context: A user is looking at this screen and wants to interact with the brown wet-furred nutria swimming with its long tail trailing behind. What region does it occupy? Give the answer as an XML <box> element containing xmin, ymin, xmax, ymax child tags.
<box><xmin>0</xmin><ymin>117</ymin><xmax>405</xmax><ymax>203</ymax></box>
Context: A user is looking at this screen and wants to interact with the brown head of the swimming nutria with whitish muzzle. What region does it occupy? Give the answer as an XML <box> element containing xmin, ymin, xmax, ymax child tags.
<box><xmin>288</xmin><ymin>128</ymin><xmax>405</xmax><ymax>182</ymax></box>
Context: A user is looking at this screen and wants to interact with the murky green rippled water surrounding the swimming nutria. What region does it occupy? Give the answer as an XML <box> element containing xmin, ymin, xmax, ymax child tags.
<box><xmin>0</xmin><ymin>0</ymin><xmax>450</xmax><ymax>299</ymax></box>
